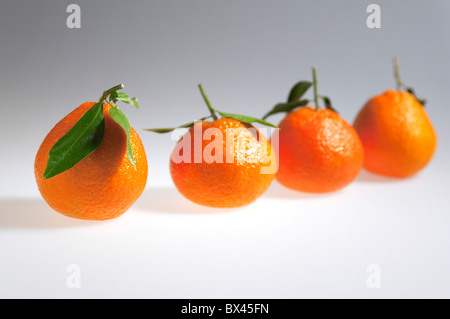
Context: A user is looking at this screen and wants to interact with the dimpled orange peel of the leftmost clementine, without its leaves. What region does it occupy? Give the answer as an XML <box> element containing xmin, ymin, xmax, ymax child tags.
<box><xmin>35</xmin><ymin>102</ymin><xmax>148</xmax><ymax>220</ymax></box>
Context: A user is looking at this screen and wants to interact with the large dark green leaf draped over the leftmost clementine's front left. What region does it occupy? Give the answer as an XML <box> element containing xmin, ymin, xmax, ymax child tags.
<box><xmin>44</xmin><ymin>103</ymin><xmax>105</xmax><ymax>179</ymax></box>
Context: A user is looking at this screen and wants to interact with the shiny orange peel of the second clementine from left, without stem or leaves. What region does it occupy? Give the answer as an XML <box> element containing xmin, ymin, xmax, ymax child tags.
<box><xmin>170</xmin><ymin>118</ymin><xmax>276</xmax><ymax>208</ymax></box>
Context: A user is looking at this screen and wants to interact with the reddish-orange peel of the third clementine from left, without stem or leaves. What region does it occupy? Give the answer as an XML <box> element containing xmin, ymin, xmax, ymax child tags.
<box><xmin>276</xmin><ymin>107</ymin><xmax>364</xmax><ymax>193</ymax></box>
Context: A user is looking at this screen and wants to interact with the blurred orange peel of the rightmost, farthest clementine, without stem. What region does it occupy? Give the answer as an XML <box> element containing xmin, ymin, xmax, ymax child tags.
<box><xmin>354</xmin><ymin>90</ymin><xmax>437</xmax><ymax>178</ymax></box>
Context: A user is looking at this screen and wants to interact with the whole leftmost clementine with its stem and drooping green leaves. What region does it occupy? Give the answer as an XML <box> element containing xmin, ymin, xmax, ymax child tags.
<box><xmin>34</xmin><ymin>85</ymin><xmax>148</xmax><ymax>220</ymax></box>
